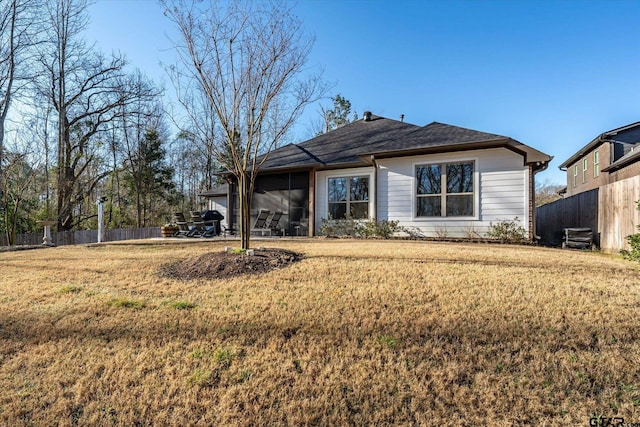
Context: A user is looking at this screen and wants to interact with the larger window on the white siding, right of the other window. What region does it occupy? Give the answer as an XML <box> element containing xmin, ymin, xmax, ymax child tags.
<box><xmin>416</xmin><ymin>162</ymin><xmax>474</xmax><ymax>217</ymax></box>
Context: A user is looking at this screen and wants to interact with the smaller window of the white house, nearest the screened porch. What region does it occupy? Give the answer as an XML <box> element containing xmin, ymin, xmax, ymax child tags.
<box><xmin>329</xmin><ymin>176</ymin><xmax>369</xmax><ymax>219</ymax></box>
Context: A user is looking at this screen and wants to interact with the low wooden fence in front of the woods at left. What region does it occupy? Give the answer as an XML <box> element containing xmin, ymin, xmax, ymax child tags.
<box><xmin>0</xmin><ymin>227</ymin><xmax>161</xmax><ymax>246</ymax></box>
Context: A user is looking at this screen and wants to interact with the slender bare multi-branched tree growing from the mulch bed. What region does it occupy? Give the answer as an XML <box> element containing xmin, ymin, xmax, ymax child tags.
<box><xmin>162</xmin><ymin>0</ymin><xmax>324</xmax><ymax>249</ymax></box>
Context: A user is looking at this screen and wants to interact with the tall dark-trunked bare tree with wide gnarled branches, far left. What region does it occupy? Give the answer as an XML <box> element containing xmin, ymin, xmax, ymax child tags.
<box><xmin>40</xmin><ymin>0</ymin><xmax>158</xmax><ymax>230</ymax></box>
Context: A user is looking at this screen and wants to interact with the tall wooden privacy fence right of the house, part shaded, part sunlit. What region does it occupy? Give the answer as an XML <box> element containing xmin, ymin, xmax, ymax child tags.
<box><xmin>536</xmin><ymin>176</ymin><xmax>640</xmax><ymax>252</ymax></box>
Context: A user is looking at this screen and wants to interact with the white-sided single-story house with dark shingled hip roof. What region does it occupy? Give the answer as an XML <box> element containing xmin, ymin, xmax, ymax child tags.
<box><xmin>204</xmin><ymin>112</ymin><xmax>551</xmax><ymax>237</ymax></box>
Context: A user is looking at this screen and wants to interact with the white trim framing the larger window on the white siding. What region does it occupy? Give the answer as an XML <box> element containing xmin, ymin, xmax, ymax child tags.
<box><xmin>411</xmin><ymin>157</ymin><xmax>480</xmax><ymax>222</ymax></box>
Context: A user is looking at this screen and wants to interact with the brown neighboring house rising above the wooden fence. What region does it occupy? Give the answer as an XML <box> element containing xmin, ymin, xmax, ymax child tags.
<box><xmin>560</xmin><ymin>122</ymin><xmax>640</xmax><ymax>197</ymax></box>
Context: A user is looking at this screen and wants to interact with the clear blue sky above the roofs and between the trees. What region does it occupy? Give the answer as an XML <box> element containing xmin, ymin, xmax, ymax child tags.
<box><xmin>87</xmin><ymin>0</ymin><xmax>640</xmax><ymax>184</ymax></box>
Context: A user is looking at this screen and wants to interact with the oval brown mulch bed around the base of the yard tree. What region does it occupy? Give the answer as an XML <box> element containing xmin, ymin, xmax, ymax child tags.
<box><xmin>160</xmin><ymin>249</ymin><xmax>303</xmax><ymax>280</ymax></box>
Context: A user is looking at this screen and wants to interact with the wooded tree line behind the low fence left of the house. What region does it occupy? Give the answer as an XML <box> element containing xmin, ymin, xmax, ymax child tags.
<box><xmin>0</xmin><ymin>0</ymin><xmax>280</xmax><ymax>246</ymax></box>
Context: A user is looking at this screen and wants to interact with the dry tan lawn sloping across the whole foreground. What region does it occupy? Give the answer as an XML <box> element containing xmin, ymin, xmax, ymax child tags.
<box><xmin>0</xmin><ymin>240</ymin><xmax>640</xmax><ymax>426</ymax></box>
